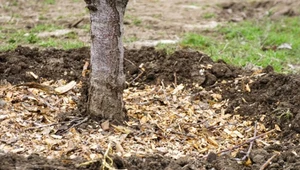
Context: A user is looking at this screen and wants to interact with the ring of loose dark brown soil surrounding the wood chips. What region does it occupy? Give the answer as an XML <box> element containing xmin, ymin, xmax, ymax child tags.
<box><xmin>0</xmin><ymin>47</ymin><xmax>300</xmax><ymax>170</ymax></box>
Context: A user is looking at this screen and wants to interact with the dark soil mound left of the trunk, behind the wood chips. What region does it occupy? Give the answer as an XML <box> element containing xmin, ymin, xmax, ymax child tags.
<box><xmin>0</xmin><ymin>46</ymin><xmax>89</xmax><ymax>84</ymax></box>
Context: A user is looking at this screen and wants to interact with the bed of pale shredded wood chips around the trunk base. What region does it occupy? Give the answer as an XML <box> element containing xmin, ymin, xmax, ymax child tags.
<box><xmin>0</xmin><ymin>80</ymin><xmax>280</xmax><ymax>160</ymax></box>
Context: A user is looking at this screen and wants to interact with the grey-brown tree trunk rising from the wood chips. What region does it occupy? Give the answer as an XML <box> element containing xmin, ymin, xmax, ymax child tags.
<box><xmin>85</xmin><ymin>0</ymin><xmax>128</xmax><ymax>122</ymax></box>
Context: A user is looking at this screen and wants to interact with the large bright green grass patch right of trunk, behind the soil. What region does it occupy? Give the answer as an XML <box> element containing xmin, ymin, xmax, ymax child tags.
<box><xmin>173</xmin><ymin>18</ymin><xmax>300</xmax><ymax>72</ymax></box>
